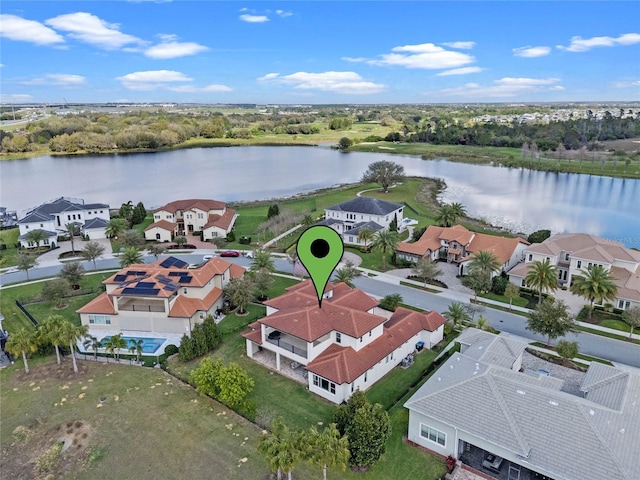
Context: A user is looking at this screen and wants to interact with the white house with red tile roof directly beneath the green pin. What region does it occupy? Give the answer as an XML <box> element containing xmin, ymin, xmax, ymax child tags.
<box><xmin>243</xmin><ymin>280</ymin><xmax>446</xmax><ymax>404</ymax></box>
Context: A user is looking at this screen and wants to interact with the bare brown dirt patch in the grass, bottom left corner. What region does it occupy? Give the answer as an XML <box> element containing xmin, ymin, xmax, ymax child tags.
<box><xmin>0</xmin><ymin>420</ymin><xmax>93</xmax><ymax>480</ymax></box>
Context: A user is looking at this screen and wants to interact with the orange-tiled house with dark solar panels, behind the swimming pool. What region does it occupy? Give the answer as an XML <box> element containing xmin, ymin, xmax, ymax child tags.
<box><xmin>76</xmin><ymin>253</ymin><xmax>245</xmax><ymax>350</ymax></box>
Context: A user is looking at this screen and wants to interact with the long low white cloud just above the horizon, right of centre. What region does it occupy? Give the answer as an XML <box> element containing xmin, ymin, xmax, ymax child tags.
<box><xmin>428</xmin><ymin>77</ymin><xmax>564</xmax><ymax>99</ymax></box>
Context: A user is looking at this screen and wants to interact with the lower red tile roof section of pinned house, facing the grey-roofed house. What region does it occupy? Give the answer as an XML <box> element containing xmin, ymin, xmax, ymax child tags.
<box><xmin>306</xmin><ymin>307</ymin><xmax>446</xmax><ymax>384</ymax></box>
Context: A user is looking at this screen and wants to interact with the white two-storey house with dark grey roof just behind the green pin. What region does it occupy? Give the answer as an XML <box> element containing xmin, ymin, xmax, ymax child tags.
<box><xmin>319</xmin><ymin>196</ymin><xmax>404</xmax><ymax>245</ymax></box>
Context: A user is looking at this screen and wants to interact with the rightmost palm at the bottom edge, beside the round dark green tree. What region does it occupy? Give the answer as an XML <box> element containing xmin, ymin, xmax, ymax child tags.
<box><xmin>303</xmin><ymin>423</ymin><xmax>350</xmax><ymax>480</ymax></box>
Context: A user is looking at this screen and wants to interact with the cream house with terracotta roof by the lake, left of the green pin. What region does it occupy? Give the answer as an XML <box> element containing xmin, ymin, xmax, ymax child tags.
<box><xmin>144</xmin><ymin>199</ymin><xmax>238</xmax><ymax>242</ymax></box>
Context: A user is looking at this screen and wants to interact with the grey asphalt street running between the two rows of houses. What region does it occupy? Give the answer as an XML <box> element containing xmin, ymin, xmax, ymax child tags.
<box><xmin>0</xmin><ymin>255</ymin><xmax>640</xmax><ymax>368</ymax></box>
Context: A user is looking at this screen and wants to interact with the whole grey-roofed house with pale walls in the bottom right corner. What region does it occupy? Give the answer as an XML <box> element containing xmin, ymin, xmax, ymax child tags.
<box><xmin>405</xmin><ymin>329</ymin><xmax>640</xmax><ymax>480</ymax></box>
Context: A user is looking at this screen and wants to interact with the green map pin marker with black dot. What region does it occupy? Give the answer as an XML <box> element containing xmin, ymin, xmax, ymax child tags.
<box><xmin>296</xmin><ymin>225</ymin><xmax>344</xmax><ymax>307</ymax></box>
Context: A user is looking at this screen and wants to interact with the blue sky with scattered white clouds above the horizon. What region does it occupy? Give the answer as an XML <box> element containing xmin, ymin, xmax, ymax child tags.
<box><xmin>0</xmin><ymin>0</ymin><xmax>640</xmax><ymax>104</ymax></box>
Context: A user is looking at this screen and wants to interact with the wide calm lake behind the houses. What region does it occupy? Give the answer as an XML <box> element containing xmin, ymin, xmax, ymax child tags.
<box><xmin>0</xmin><ymin>147</ymin><xmax>640</xmax><ymax>248</ymax></box>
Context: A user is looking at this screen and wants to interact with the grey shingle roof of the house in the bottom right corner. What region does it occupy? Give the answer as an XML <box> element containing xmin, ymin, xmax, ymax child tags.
<box><xmin>405</xmin><ymin>338</ymin><xmax>640</xmax><ymax>480</ymax></box>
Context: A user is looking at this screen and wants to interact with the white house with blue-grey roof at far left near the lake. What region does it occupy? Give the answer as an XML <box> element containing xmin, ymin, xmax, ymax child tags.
<box><xmin>18</xmin><ymin>197</ymin><xmax>109</xmax><ymax>248</ymax></box>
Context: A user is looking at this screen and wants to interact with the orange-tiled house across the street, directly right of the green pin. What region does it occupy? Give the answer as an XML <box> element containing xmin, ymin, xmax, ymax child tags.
<box><xmin>396</xmin><ymin>225</ymin><xmax>529</xmax><ymax>276</ymax></box>
